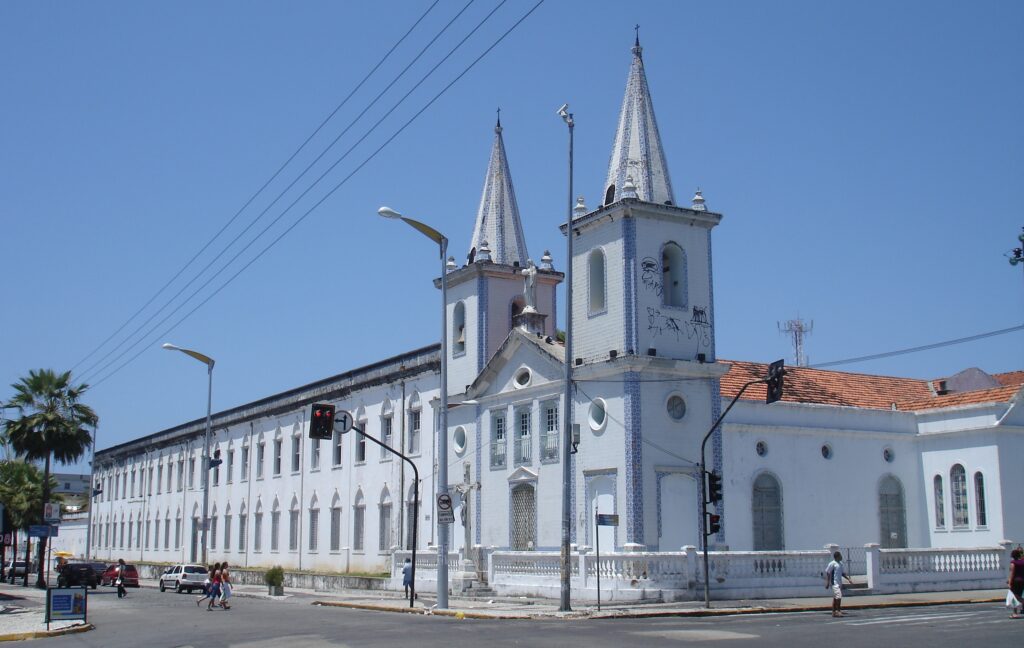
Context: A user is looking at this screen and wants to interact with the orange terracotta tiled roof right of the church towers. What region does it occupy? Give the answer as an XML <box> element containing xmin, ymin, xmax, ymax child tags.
<box><xmin>719</xmin><ymin>360</ymin><xmax>1024</xmax><ymax>411</ymax></box>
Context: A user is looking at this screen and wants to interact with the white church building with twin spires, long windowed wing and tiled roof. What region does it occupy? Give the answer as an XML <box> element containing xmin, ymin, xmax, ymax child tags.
<box><xmin>90</xmin><ymin>37</ymin><xmax>1024</xmax><ymax>572</ymax></box>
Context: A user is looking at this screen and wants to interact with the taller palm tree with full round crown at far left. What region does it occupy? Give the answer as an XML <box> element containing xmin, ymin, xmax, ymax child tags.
<box><xmin>5</xmin><ymin>369</ymin><xmax>98</xmax><ymax>588</ymax></box>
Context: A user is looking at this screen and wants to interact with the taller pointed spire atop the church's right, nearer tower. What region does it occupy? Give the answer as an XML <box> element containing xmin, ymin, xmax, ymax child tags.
<box><xmin>602</xmin><ymin>34</ymin><xmax>676</xmax><ymax>205</ymax></box>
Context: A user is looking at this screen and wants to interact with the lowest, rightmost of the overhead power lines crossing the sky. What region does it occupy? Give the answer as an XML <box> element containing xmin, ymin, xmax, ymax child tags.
<box><xmin>93</xmin><ymin>0</ymin><xmax>544</xmax><ymax>386</ymax></box>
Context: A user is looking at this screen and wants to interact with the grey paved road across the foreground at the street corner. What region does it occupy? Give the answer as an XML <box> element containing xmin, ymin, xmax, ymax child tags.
<box><xmin>18</xmin><ymin>588</ymin><xmax>1024</xmax><ymax>648</ymax></box>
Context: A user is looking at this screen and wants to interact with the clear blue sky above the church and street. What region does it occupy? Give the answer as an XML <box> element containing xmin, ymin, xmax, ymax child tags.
<box><xmin>0</xmin><ymin>0</ymin><xmax>1024</xmax><ymax>464</ymax></box>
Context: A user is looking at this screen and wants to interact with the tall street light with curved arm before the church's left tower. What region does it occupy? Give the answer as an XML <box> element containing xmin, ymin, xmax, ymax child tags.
<box><xmin>377</xmin><ymin>207</ymin><xmax>449</xmax><ymax>610</ymax></box>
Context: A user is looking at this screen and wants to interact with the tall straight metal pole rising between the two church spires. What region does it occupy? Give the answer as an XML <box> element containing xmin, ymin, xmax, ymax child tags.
<box><xmin>558</xmin><ymin>107</ymin><xmax>574</xmax><ymax>612</ymax></box>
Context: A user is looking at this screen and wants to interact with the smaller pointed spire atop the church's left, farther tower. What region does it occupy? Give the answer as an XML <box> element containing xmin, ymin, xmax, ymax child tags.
<box><xmin>470</xmin><ymin>116</ymin><xmax>527</xmax><ymax>265</ymax></box>
